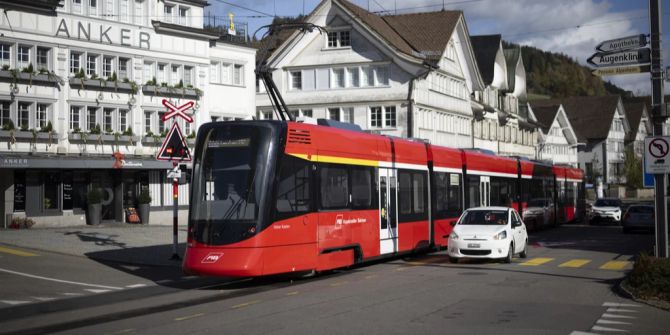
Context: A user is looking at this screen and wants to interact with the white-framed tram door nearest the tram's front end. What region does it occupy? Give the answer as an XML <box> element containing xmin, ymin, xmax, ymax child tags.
<box><xmin>377</xmin><ymin>168</ymin><xmax>398</xmax><ymax>255</ymax></box>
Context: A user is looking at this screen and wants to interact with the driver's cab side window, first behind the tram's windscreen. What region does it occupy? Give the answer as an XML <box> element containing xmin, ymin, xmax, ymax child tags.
<box><xmin>276</xmin><ymin>155</ymin><xmax>311</xmax><ymax>219</ymax></box>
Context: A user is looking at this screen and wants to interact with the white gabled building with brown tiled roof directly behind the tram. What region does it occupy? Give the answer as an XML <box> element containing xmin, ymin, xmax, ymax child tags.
<box><xmin>257</xmin><ymin>0</ymin><xmax>483</xmax><ymax>147</ymax></box>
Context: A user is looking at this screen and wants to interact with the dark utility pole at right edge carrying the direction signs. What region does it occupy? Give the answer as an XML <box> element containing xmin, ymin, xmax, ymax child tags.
<box><xmin>649</xmin><ymin>0</ymin><xmax>668</xmax><ymax>258</ymax></box>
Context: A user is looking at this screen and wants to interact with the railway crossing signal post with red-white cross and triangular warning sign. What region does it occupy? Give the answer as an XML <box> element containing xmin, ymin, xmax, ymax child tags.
<box><xmin>156</xmin><ymin>99</ymin><xmax>193</xmax><ymax>260</ymax></box>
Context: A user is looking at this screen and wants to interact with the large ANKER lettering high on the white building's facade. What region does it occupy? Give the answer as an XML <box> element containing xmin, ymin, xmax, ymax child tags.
<box><xmin>55</xmin><ymin>19</ymin><xmax>151</xmax><ymax>49</ymax></box>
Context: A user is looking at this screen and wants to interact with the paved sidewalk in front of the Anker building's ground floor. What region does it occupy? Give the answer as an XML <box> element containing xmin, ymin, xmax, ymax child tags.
<box><xmin>0</xmin><ymin>224</ymin><xmax>187</xmax><ymax>267</ymax></box>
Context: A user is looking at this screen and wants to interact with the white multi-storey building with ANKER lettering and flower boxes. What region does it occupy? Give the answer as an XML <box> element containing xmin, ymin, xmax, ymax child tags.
<box><xmin>0</xmin><ymin>0</ymin><xmax>255</xmax><ymax>224</ymax></box>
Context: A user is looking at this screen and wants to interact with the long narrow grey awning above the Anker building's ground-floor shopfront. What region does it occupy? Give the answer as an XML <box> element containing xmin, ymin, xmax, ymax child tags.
<box><xmin>0</xmin><ymin>154</ymin><xmax>172</xmax><ymax>170</ymax></box>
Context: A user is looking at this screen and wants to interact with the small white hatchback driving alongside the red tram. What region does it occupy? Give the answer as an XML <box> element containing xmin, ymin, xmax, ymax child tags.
<box><xmin>448</xmin><ymin>207</ymin><xmax>528</xmax><ymax>263</ymax></box>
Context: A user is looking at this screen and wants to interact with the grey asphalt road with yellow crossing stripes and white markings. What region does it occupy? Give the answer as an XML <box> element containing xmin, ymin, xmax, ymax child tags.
<box><xmin>0</xmin><ymin>226</ymin><xmax>670</xmax><ymax>335</ymax></box>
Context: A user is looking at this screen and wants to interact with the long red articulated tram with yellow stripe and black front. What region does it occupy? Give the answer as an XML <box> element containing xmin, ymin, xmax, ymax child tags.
<box><xmin>183</xmin><ymin>121</ymin><xmax>583</xmax><ymax>277</ymax></box>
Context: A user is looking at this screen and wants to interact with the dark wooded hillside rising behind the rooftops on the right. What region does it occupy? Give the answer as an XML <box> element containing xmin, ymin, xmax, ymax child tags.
<box><xmin>503</xmin><ymin>42</ymin><xmax>631</xmax><ymax>98</ymax></box>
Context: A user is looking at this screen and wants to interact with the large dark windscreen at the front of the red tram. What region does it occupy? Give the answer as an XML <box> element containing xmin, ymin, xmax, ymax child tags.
<box><xmin>191</xmin><ymin>125</ymin><xmax>271</xmax><ymax>245</ymax></box>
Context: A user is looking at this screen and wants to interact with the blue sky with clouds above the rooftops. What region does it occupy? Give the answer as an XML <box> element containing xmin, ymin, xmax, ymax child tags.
<box><xmin>206</xmin><ymin>0</ymin><xmax>670</xmax><ymax>95</ymax></box>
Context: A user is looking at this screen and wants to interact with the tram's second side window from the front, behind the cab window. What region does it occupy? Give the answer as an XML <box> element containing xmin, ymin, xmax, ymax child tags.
<box><xmin>319</xmin><ymin>165</ymin><xmax>349</xmax><ymax>209</ymax></box>
